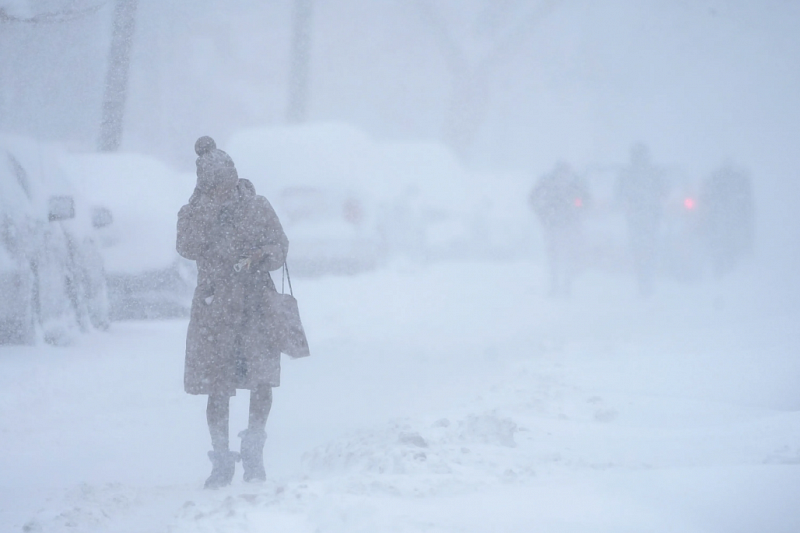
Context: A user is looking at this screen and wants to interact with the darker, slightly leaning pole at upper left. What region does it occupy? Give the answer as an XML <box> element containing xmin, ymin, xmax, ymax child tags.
<box><xmin>97</xmin><ymin>0</ymin><xmax>138</xmax><ymax>152</ymax></box>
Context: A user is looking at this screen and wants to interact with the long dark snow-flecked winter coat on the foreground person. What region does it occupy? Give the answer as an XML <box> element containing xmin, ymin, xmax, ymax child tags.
<box><xmin>177</xmin><ymin>179</ymin><xmax>289</xmax><ymax>396</ymax></box>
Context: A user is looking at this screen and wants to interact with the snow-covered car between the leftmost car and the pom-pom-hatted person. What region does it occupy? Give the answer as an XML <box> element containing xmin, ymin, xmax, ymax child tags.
<box><xmin>64</xmin><ymin>153</ymin><xmax>197</xmax><ymax>320</ymax></box>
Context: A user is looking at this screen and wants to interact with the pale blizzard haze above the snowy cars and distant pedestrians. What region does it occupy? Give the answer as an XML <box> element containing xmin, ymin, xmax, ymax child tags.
<box><xmin>0</xmin><ymin>0</ymin><xmax>800</xmax><ymax>282</ymax></box>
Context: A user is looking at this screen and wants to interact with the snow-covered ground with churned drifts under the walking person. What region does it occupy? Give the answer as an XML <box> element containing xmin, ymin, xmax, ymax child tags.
<box><xmin>0</xmin><ymin>262</ymin><xmax>800</xmax><ymax>533</ymax></box>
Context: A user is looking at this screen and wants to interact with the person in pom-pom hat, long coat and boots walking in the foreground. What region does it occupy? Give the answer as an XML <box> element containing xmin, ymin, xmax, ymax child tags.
<box><xmin>177</xmin><ymin>137</ymin><xmax>289</xmax><ymax>488</ymax></box>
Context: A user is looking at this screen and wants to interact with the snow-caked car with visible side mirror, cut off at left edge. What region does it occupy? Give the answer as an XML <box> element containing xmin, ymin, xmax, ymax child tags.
<box><xmin>0</xmin><ymin>135</ymin><xmax>109</xmax><ymax>345</ymax></box>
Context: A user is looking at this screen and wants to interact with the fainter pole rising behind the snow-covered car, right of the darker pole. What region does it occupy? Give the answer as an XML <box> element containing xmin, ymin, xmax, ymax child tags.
<box><xmin>286</xmin><ymin>0</ymin><xmax>314</xmax><ymax>124</ymax></box>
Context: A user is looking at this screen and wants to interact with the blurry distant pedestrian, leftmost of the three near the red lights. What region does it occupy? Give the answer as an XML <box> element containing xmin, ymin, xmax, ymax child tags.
<box><xmin>528</xmin><ymin>162</ymin><xmax>589</xmax><ymax>296</ymax></box>
